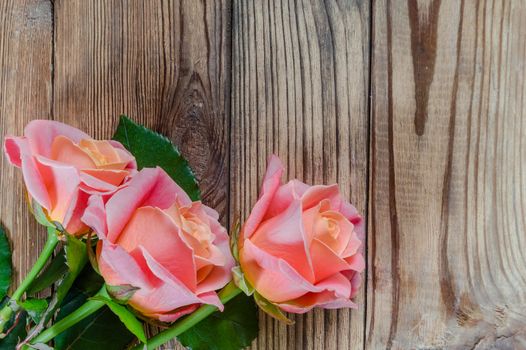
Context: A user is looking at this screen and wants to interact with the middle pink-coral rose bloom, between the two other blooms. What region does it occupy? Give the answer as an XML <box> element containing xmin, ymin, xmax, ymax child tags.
<box><xmin>83</xmin><ymin>168</ymin><xmax>234</xmax><ymax>322</ymax></box>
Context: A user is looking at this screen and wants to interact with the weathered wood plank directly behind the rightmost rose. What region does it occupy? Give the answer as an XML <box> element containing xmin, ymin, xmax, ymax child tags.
<box><xmin>230</xmin><ymin>0</ymin><xmax>370</xmax><ymax>349</ymax></box>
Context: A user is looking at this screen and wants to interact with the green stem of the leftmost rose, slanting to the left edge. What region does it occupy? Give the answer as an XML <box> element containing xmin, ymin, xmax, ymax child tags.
<box><xmin>0</xmin><ymin>228</ymin><xmax>59</xmax><ymax>333</ymax></box>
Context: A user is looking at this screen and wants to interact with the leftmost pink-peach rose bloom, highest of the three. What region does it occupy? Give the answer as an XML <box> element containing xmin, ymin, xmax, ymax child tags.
<box><xmin>4</xmin><ymin>120</ymin><xmax>137</xmax><ymax>234</ymax></box>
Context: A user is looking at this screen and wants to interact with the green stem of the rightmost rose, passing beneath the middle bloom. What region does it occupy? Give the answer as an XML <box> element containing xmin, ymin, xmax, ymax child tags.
<box><xmin>134</xmin><ymin>281</ymin><xmax>241</xmax><ymax>350</ymax></box>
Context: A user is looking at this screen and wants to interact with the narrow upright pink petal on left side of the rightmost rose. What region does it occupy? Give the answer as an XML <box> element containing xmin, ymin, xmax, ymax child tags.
<box><xmin>241</xmin><ymin>155</ymin><xmax>283</xmax><ymax>238</ymax></box>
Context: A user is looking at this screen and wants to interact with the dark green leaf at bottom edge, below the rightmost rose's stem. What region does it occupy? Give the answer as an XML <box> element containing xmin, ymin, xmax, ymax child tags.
<box><xmin>178</xmin><ymin>294</ymin><xmax>259</xmax><ymax>350</ymax></box>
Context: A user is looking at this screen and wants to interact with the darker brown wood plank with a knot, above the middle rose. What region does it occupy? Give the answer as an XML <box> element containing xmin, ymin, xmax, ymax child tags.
<box><xmin>53</xmin><ymin>0</ymin><xmax>231</xmax><ymax>348</ymax></box>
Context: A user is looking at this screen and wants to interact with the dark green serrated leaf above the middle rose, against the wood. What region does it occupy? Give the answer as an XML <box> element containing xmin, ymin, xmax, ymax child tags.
<box><xmin>113</xmin><ymin>115</ymin><xmax>200</xmax><ymax>201</ymax></box>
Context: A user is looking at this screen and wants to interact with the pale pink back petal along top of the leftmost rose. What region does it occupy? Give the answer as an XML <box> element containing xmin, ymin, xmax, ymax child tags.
<box><xmin>24</xmin><ymin>120</ymin><xmax>91</xmax><ymax>158</ymax></box>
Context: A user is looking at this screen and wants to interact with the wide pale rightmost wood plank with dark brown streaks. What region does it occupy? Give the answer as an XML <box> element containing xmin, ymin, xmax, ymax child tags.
<box><xmin>366</xmin><ymin>0</ymin><xmax>526</xmax><ymax>349</ymax></box>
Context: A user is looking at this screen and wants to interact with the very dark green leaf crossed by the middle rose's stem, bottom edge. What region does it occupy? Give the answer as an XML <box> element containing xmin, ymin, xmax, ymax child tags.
<box><xmin>55</xmin><ymin>287</ymin><xmax>135</xmax><ymax>350</ymax></box>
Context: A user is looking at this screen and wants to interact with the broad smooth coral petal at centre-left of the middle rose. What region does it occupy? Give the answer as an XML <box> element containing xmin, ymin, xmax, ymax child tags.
<box><xmin>115</xmin><ymin>207</ymin><xmax>197</xmax><ymax>290</ymax></box>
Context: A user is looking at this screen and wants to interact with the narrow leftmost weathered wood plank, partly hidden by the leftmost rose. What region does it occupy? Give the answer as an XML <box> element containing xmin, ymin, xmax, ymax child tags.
<box><xmin>0</xmin><ymin>0</ymin><xmax>52</xmax><ymax>294</ymax></box>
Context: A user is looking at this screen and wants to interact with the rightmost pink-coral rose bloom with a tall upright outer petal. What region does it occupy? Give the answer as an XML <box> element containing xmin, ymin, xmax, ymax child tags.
<box><xmin>238</xmin><ymin>156</ymin><xmax>365</xmax><ymax>313</ymax></box>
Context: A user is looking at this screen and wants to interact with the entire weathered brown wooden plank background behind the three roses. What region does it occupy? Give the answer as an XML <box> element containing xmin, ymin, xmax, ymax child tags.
<box><xmin>0</xmin><ymin>0</ymin><xmax>526</xmax><ymax>350</ymax></box>
